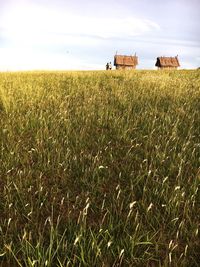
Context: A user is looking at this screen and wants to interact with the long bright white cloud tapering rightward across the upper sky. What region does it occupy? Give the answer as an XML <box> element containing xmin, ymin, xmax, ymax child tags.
<box><xmin>1</xmin><ymin>2</ymin><xmax>159</xmax><ymax>43</ymax></box>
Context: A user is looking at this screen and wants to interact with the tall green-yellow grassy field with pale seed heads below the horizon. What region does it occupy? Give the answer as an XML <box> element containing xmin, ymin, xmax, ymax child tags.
<box><xmin>0</xmin><ymin>70</ymin><xmax>200</xmax><ymax>267</ymax></box>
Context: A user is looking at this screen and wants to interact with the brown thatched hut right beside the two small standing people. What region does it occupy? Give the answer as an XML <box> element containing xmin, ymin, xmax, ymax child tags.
<box><xmin>114</xmin><ymin>55</ymin><xmax>138</xmax><ymax>69</ymax></box>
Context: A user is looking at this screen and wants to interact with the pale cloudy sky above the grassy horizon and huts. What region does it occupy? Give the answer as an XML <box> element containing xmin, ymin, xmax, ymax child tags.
<box><xmin>0</xmin><ymin>0</ymin><xmax>200</xmax><ymax>71</ymax></box>
